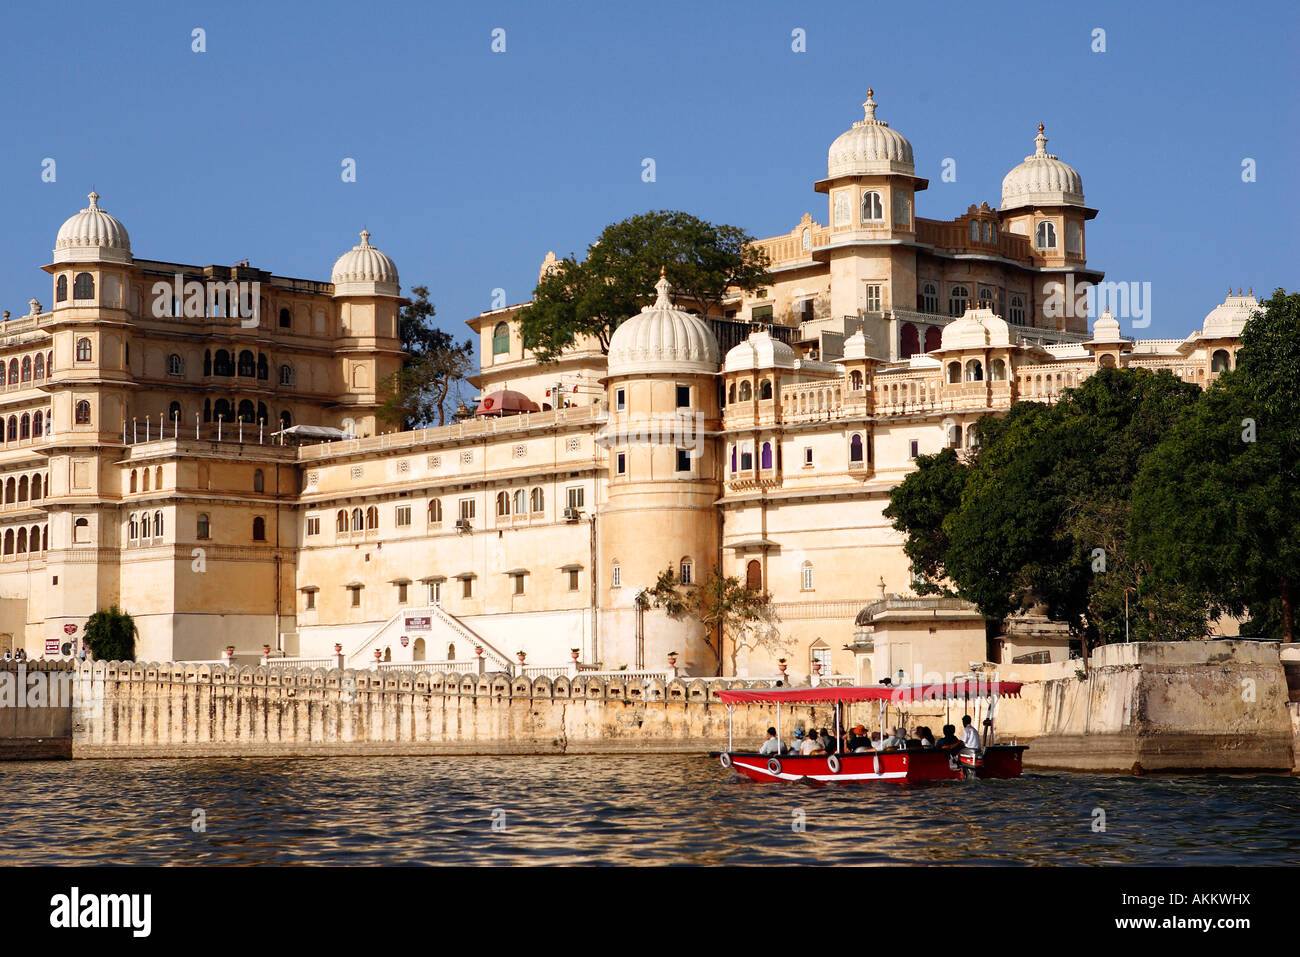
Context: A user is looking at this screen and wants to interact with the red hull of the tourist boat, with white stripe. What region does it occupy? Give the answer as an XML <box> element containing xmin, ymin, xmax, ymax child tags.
<box><xmin>718</xmin><ymin>745</ymin><xmax>1026</xmax><ymax>784</ymax></box>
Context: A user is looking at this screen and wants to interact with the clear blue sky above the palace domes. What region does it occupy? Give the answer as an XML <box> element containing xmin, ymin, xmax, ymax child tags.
<box><xmin>0</xmin><ymin>0</ymin><xmax>1300</xmax><ymax>337</ymax></box>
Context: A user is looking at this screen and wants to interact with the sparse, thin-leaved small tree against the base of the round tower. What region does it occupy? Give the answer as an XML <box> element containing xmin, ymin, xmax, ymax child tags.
<box><xmin>637</xmin><ymin>566</ymin><xmax>787</xmax><ymax>675</ymax></box>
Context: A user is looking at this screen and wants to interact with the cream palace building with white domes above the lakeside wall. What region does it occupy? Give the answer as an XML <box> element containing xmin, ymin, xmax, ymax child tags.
<box><xmin>0</xmin><ymin>91</ymin><xmax>1258</xmax><ymax>680</ymax></box>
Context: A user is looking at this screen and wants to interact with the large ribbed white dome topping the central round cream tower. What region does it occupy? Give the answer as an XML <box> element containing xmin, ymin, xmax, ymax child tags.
<box><xmin>606</xmin><ymin>274</ymin><xmax>718</xmax><ymax>376</ymax></box>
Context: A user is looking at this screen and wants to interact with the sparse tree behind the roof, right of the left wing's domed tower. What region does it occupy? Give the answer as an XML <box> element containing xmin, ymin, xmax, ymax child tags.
<box><xmin>378</xmin><ymin>286</ymin><xmax>475</xmax><ymax>429</ymax></box>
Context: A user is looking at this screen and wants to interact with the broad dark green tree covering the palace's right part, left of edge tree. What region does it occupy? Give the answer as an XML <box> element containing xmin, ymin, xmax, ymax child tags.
<box><xmin>885</xmin><ymin>369</ymin><xmax>1206</xmax><ymax>642</ymax></box>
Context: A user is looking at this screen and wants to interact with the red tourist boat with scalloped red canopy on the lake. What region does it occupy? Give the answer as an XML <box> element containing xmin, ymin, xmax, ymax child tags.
<box><xmin>714</xmin><ymin>679</ymin><xmax>1026</xmax><ymax>784</ymax></box>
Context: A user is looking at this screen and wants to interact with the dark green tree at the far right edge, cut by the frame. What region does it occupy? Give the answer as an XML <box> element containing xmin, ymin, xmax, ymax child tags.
<box><xmin>1132</xmin><ymin>290</ymin><xmax>1300</xmax><ymax>641</ymax></box>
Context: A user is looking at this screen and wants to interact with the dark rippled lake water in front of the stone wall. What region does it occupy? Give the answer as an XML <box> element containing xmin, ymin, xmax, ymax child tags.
<box><xmin>0</xmin><ymin>755</ymin><xmax>1300</xmax><ymax>865</ymax></box>
